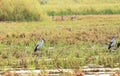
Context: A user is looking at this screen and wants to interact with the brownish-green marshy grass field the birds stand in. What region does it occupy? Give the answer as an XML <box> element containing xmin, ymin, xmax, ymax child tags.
<box><xmin>0</xmin><ymin>15</ymin><xmax>120</xmax><ymax>69</ymax></box>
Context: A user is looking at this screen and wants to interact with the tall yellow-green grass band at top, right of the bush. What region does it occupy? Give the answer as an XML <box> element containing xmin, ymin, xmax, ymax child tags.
<box><xmin>39</xmin><ymin>0</ymin><xmax>120</xmax><ymax>16</ymax></box>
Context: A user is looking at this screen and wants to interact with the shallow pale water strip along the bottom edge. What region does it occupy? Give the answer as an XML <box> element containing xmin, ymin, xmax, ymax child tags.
<box><xmin>1</xmin><ymin>68</ymin><xmax>120</xmax><ymax>76</ymax></box>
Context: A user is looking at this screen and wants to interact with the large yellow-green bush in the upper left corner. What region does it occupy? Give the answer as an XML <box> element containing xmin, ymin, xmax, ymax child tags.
<box><xmin>0</xmin><ymin>0</ymin><xmax>47</xmax><ymax>21</ymax></box>
